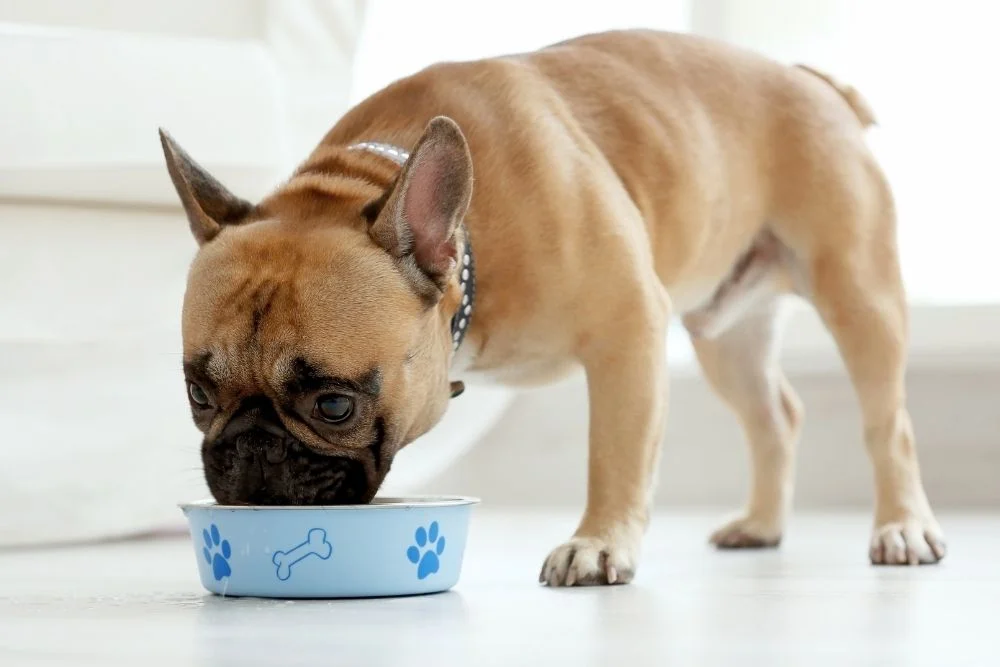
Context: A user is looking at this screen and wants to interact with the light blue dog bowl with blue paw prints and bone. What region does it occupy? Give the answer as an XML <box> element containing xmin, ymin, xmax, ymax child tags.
<box><xmin>181</xmin><ymin>496</ymin><xmax>479</xmax><ymax>598</ymax></box>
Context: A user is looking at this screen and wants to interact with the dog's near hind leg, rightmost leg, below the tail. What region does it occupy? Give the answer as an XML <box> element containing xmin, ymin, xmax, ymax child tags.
<box><xmin>806</xmin><ymin>168</ymin><xmax>945</xmax><ymax>565</ymax></box>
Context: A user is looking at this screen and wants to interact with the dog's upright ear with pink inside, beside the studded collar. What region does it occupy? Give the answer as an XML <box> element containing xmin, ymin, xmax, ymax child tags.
<box><xmin>369</xmin><ymin>116</ymin><xmax>472</xmax><ymax>300</ymax></box>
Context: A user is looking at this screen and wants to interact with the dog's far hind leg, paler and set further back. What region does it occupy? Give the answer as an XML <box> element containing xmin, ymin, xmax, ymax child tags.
<box><xmin>692</xmin><ymin>294</ymin><xmax>803</xmax><ymax>548</ymax></box>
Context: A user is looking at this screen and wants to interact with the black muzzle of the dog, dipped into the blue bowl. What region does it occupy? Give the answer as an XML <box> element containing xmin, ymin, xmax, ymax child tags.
<box><xmin>201</xmin><ymin>397</ymin><xmax>374</xmax><ymax>505</ymax></box>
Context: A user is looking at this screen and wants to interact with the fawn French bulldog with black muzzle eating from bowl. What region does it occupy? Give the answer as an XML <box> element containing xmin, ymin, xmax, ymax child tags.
<box><xmin>161</xmin><ymin>30</ymin><xmax>945</xmax><ymax>586</ymax></box>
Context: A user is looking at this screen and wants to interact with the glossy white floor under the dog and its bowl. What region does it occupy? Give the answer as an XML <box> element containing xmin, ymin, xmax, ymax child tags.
<box><xmin>0</xmin><ymin>510</ymin><xmax>1000</xmax><ymax>667</ymax></box>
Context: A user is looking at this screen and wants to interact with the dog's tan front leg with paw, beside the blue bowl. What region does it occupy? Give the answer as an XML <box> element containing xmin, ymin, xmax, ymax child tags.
<box><xmin>539</xmin><ymin>282</ymin><xmax>669</xmax><ymax>586</ymax></box>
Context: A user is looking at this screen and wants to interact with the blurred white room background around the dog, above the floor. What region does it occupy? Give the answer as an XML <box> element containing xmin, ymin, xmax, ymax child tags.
<box><xmin>0</xmin><ymin>0</ymin><xmax>1000</xmax><ymax>544</ymax></box>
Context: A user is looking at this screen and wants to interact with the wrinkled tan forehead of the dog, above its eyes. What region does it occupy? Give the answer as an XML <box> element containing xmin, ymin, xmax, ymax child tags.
<box><xmin>183</xmin><ymin>223</ymin><xmax>422</xmax><ymax>383</ymax></box>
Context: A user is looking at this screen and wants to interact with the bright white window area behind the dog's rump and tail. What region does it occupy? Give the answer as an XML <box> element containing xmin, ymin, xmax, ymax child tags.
<box><xmin>692</xmin><ymin>0</ymin><xmax>1000</xmax><ymax>306</ymax></box>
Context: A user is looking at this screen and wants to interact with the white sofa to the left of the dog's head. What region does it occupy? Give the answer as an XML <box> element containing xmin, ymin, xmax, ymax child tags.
<box><xmin>0</xmin><ymin>1</ymin><xmax>284</xmax><ymax>544</ymax></box>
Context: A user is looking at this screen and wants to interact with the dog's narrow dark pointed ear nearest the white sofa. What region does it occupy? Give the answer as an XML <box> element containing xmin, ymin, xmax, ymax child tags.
<box><xmin>160</xmin><ymin>129</ymin><xmax>253</xmax><ymax>245</ymax></box>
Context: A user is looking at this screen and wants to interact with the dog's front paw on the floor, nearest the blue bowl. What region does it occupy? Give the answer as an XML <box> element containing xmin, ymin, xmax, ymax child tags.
<box><xmin>538</xmin><ymin>537</ymin><xmax>636</xmax><ymax>586</ymax></box>
